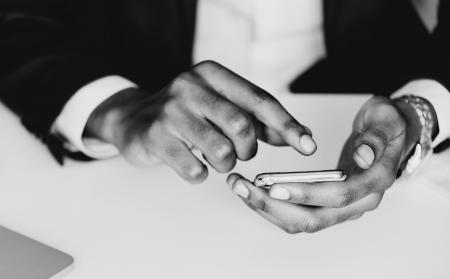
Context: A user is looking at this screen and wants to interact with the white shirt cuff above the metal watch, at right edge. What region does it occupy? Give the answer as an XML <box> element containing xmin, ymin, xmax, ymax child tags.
<box><xmin>392</xmin><ymin>79</ymin><xmax>450</xmax><ymax>147</ymax></box>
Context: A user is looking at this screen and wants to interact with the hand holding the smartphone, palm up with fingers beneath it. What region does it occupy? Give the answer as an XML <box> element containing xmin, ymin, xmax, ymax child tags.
<box><xmin>228</xmin><ymin>97</ymin><xmax>428</xmax><ymax>233</ymax></box>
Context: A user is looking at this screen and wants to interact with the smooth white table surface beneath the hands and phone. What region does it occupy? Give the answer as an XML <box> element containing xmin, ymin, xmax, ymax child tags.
<box><xmin>0</xmin><ymin>95</ymin><xmax>450</xmax><ymax>279</ymax></box>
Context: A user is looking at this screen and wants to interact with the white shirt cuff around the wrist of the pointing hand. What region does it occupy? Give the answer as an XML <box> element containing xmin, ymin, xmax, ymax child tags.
<box><xmin>52</xmin><ymin>76</ymin><xmax>137</xmax><ymax>159</ymax></box>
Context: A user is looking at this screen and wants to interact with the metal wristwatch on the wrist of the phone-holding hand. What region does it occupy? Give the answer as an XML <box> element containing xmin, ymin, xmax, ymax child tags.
<box><xmin>396</xmin><ymin>95</ymin><xmax>434</xmax><ymax>176</ymax></box>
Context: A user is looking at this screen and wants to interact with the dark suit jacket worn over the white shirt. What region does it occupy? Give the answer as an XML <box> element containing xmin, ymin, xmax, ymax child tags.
<box><xmin>0</xmin><ymin>0</ymin><xmax>450</xmax><ymax>162</ymax></box>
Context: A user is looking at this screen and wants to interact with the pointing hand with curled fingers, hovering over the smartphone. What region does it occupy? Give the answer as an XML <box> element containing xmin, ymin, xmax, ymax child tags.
<box><xmin>86</xmin><ymin>61</ymin><xmax>316</xmax><ymax>183</ymax></box>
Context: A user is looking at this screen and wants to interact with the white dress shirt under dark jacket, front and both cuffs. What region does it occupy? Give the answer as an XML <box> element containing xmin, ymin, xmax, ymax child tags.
<box><xmin>53</xmin><ymin>0</ymin><xmax>450</xmax><ymax>159</ymax></box>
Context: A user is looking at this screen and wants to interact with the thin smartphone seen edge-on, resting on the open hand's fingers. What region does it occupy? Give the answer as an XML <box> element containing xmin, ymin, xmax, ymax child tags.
<box><xmin>254</xmin><ymin>170</ymin><xmax>347</xmax><ymax>187</ymax></box>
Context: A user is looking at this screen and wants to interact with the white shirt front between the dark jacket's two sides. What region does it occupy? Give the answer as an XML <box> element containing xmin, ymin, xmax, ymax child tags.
<box><xmin>193</xmin><ymin>0</ymin><xmax>325</xmax><ymax>94</ymax></box>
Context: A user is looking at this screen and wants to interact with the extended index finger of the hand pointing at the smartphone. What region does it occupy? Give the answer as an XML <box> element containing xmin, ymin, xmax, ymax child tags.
<box><xmin>195</xmin><ymin>61</ymin><xmax>317</xmax><ymax>155</ymax></box>
